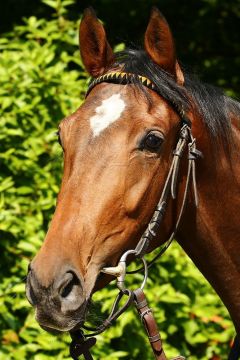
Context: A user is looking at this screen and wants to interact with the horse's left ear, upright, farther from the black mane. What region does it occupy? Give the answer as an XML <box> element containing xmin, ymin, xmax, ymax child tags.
<box><xmin>79</xmin><ymin>8</ymin><xmax>114</xmax><ymax>77</ymax></box>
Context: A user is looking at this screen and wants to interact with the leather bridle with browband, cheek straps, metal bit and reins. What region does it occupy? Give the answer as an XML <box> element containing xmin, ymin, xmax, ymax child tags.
<box><xmin>70</xmin><ymin>72</ymin><xmax>239</xmax><ymax>360</ymax></box>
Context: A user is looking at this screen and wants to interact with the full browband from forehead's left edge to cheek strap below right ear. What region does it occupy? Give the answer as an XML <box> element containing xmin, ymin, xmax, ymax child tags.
<box><xmin>86</xmin><ymin>71</ymin><xmax>191</xmax><ymax>127</ymax></box>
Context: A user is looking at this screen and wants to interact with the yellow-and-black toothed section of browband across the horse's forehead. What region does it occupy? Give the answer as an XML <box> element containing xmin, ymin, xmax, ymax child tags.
<box><xmin>86</xmin><ymin>71</ymin><xmax>156</xmax><ymax>96</ymax></box>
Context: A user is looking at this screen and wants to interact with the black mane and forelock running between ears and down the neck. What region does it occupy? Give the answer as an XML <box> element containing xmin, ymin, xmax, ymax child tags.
<box><xmin>113</xmin><ymin>49</ymin><xmax>240</xmax><ymax>150</ymax></box>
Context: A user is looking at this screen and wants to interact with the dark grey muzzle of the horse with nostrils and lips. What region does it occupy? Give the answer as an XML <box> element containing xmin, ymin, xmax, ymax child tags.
<box><xmin>26</xmin><ymin>267</ymin><xmax>87</xmax><ymax>331</ymax></box>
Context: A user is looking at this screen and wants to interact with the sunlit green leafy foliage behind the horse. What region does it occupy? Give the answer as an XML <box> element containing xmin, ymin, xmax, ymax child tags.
<box><xmin>0</xmin><ymin>0</ymin><xmax>236</xmax><ymax>360</ymax></box>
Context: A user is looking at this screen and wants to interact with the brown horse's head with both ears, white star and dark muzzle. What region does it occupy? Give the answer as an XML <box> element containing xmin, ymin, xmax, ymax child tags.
<box><xmin>27</xmin><ymin>9</ymin><xmax>196</xmax><ymax>331</ymax></box>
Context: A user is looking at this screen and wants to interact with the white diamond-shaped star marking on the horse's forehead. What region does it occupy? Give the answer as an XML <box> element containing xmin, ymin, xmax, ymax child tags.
<box><xmin>90</xmin><ymin>94</ymin><xmax>125</xmax><ymax>136</ymax></box>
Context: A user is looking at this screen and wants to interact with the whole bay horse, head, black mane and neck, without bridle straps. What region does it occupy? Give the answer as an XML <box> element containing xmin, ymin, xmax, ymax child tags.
<box><xmin>26</xmin><ymin>8</ymin><xmax>240</xmax><ymax>358</ymax></box>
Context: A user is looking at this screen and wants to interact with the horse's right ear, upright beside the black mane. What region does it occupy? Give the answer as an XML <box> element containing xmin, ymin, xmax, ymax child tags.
<box><xmin>144</xmin><ymin>7</ymin><xmax>184</xmax><ymax>85</ymax></box>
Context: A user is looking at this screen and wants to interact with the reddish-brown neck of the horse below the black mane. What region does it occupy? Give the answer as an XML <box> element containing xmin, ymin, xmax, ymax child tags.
<box><xmin>178</xmin><ymin>121</ymin><xmax>240</xmax><ymax>334</ymax></box>
